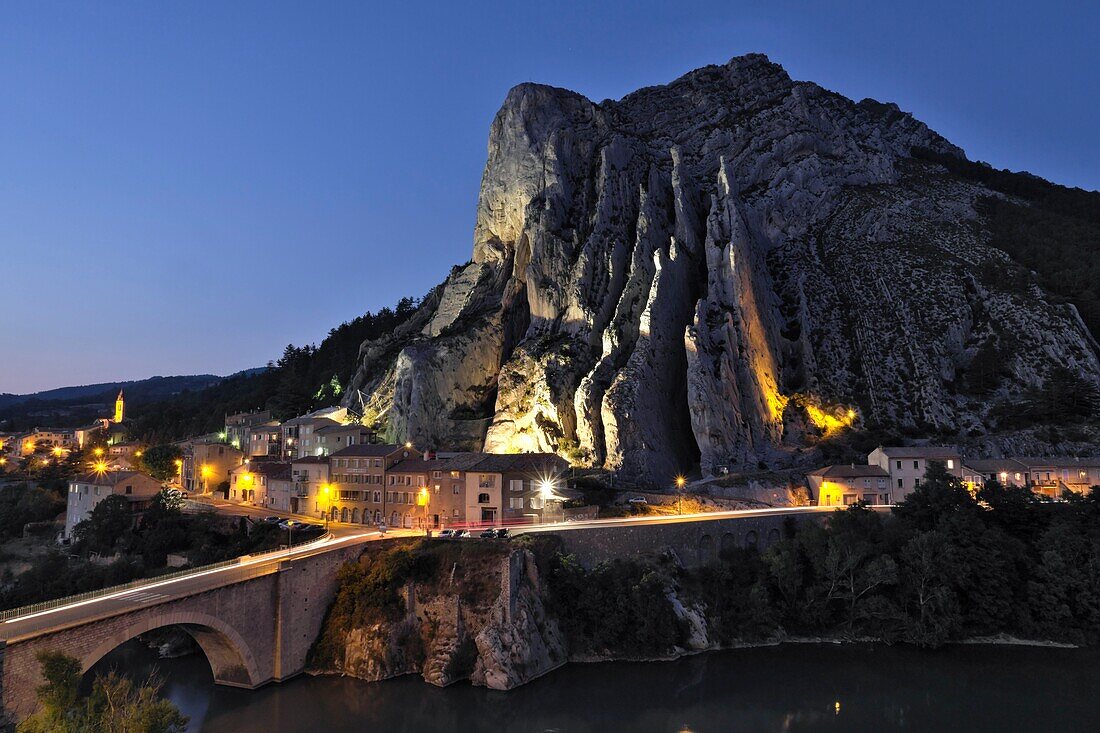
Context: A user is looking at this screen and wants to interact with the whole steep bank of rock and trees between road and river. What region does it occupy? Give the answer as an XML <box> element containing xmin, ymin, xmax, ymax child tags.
<box><xmin>311</xmin><ymin>482</ymin><xmax>1100</xmax><ymax>690</ymax></box>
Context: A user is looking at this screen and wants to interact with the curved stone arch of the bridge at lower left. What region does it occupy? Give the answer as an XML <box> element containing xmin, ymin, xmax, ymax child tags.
<box><xmin>80</xmin><ymin>611</ymin><xmax>265</xmax><ymax>689</ymax></box>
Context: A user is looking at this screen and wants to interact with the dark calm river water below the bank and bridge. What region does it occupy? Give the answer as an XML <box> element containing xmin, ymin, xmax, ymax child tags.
<box><xmin>97</xmin><ymin>642</ymin><xmax>1100</xmax><ymax>733</ymax></box>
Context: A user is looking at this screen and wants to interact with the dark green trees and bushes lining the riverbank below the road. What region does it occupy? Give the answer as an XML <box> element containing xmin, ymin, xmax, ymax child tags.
<box><xmin>549</xmin><ymin>466</ymin><xmax>1100</xmax><ymax>657</ymax></box>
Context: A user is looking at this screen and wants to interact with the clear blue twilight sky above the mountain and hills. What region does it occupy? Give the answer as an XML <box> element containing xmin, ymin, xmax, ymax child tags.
<box><xmin>0</xmin><ymin>0</ymin><xmax>1100</xmax><ymax>392</ymax></box>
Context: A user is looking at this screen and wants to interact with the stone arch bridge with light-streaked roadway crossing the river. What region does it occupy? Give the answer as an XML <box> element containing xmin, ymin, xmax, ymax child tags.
<box><xmin>0</xmin><ymin>539</ymin><xmax>362</xmax><ymax>720</ymax></box>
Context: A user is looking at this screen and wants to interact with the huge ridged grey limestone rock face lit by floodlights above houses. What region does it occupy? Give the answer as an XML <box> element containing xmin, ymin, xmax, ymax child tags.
<box><xmin>348</xmin><ymin>55</ymin><xmax>1100</xmax><ymax>483</ymax></box>
